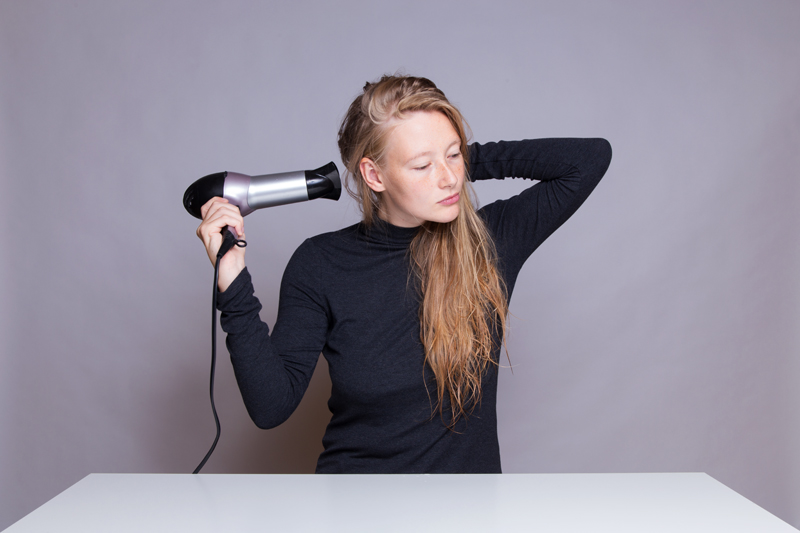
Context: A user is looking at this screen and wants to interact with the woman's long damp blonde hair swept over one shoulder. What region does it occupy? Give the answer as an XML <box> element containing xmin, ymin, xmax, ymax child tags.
<box><xmin>339</xmin><ymin>76</ymin><xmax>508</xmax><ymax>428</ymax></box>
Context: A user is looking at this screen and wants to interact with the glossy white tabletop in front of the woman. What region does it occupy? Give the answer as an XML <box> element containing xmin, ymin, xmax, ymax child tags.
<box><xmin>6</xmin><ymin>473</ymin><xmax>798</xmax><ymax>533</ymax></box>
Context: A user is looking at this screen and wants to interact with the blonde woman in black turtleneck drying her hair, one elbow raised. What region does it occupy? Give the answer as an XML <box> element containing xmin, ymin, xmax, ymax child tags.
<box><xmin>197</xmin><ymin>76</ymin><xmax>611</xmax><ymax>473</ymax></box>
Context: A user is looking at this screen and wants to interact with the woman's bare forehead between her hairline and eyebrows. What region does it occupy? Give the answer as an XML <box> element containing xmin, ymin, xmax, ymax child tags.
<box><xmin>386</xmin><ymin>111</ymin><xmax>461</xmax><ymax>157</ymax></box>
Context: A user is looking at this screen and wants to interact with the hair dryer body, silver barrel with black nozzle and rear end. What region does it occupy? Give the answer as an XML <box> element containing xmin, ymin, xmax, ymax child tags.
<box><xmin>183</xmin><ymin>161</ymin><xmax>342</xmax><ymax>218</ymax></box>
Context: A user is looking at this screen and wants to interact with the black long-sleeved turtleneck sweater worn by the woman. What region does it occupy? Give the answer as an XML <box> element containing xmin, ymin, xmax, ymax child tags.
<box><xmin>218</xmin><ymin>139</ymin><xmax>611</xmax><ymax>473</ymax></box>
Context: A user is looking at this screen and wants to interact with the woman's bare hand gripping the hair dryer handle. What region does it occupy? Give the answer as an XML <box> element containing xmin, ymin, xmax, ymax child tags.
<box><xmin>197</xmin><ymin>196</ymin><xmax>244</xmax><ymax>292</ymax></box>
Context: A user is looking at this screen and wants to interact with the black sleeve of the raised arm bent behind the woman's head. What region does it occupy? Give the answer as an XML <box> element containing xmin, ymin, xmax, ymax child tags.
<box><xmin>470</xmin><ymin>135</ymin><xmax>611</xmax><ymax>293</ymax></box>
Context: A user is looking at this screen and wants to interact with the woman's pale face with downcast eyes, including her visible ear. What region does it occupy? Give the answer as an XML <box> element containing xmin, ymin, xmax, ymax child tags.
<box><xmin>361</xmin><ymin>111</ymin><xmax>464</xmax><ymax>228</ymax></box>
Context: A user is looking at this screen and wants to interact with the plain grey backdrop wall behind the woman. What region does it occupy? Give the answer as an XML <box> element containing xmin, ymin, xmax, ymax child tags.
<box><xmin>0</xmin><ymin>0</ymin><xmax>800</xmax><ymax>528</ymax></box>
